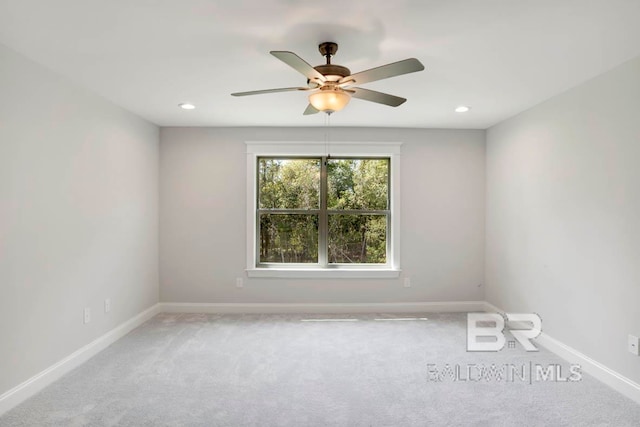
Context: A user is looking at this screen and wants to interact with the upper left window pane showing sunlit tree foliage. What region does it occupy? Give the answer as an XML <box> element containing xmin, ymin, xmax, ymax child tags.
<box><xmin>258</xmin><ymin>158</ymin><xmax>320</xmax><ymax>209</ymax></box>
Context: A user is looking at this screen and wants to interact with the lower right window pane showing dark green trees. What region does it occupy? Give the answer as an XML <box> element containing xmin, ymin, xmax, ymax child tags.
<box><xmin>328</xmin><ymin>214</ymin><xmax>387</xmax><ymax>264</ymax></box>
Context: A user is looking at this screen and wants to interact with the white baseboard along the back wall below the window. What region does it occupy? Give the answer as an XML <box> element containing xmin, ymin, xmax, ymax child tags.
<box><xmin>160</xmin><ymin>301</ymin><xmax>485</xmax><ymax>314</ymax></box>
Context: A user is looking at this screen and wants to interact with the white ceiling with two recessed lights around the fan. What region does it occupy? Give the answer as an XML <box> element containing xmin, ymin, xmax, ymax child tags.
<box><xmin>0</xmin><ymin>0</ymin><xmax>640</xmax><ymax>128</ymax></box>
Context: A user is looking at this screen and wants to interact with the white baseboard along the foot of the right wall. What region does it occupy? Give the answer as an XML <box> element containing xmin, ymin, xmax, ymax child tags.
<box><xmin>484</xmin><ymin>302</ymin><xmax>640</xmax><ymax>404</ymax></box>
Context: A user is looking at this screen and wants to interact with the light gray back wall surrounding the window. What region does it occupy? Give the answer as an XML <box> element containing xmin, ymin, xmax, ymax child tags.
<box><xmin>160</xmin><ymin>128</ymin><xmax>485</xmax><ymax>303</ymax></box>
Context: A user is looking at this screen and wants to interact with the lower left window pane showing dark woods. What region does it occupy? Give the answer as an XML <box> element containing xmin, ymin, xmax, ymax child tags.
<box><xmin>260</xmin><ymin>214</ymin><xmax>318</xmax><ymax>263</ymax></box>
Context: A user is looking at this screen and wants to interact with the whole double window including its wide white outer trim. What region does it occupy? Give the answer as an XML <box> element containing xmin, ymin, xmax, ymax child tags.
<box><xmin>247</xmin><ymin>143</ymin><xmax>399</xmax><ymax>277</ymax></box>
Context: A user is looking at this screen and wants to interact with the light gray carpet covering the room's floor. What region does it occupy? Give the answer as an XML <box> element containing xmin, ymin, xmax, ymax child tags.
<box><xmin>0</xmin><ymin>314</ymin><xmax>640</xmax><ymax>427</ymax></box>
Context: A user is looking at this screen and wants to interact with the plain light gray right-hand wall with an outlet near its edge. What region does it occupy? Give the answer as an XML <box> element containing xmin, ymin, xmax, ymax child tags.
<box><xmin>486</xmin><ymin>54</ymin><xmax>640</xmax><ymax>382</ymax></box>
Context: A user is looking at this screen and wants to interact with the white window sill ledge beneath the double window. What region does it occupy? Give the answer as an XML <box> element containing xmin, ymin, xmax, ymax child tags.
<box><xmin>247</xmin><ymin>268</ymin><xmax>401</xmax><ymax>279</ymax></box>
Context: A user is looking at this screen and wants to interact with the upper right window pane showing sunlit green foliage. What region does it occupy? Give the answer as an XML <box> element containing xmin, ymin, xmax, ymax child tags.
<box><xmin>327</xmin><ymin>159</ymin><xmax>389</xmax><ymax>210</ymax></box>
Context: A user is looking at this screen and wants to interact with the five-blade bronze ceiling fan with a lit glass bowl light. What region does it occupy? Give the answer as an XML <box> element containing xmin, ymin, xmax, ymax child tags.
<box><xmin>231</xmin><ymin>42</ymin><xmax>424</xmax><ymax>115</ymax></box>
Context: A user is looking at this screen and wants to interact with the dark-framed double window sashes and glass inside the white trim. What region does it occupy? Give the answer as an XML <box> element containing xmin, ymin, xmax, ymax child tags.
<box><xmin>256</xmin><ymin>157</ymin><xmax>390</xmax><ymax>267</ymax></box>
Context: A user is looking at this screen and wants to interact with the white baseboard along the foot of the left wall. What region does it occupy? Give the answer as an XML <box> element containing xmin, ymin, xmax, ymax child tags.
<box><xmin>0</xmin><ymin>304</ymin><xmax>160</xmax><ymax>415</ymax></box>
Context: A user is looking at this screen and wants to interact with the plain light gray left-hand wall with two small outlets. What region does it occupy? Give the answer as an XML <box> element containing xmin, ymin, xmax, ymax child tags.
<box><xmin>0</xmin><ymin>45</ymin><xmax>158</xmax><ymax>394</ymax></box>
